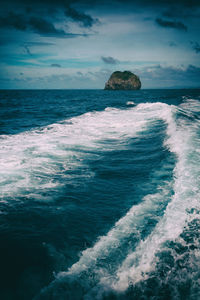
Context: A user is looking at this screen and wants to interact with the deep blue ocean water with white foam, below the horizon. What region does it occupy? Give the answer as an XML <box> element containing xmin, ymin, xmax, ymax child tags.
<box><xmin>0</xmin><ymin>90</ymin><xmax>200</xmax><ymax>300</ymax></box>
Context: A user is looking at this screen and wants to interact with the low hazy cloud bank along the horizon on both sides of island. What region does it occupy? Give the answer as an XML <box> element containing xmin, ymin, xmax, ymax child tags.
<box><xmin>0</xmin><ymin>65</ymin><xmax>200</xmax><ymax>89</ymax></box>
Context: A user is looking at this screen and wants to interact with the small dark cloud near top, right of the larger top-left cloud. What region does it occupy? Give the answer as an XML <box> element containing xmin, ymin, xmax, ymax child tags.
<box><xmin>65</xmin><ymin>5</ymin><xmax>99</xmax><ymax>27</ymax></box>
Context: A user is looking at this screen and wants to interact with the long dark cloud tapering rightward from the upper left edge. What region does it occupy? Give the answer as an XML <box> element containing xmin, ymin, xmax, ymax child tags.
<box><xmin>0</xmin><ymin>12</ymin><xmax>85</xmax><ymax>37</ymax></box>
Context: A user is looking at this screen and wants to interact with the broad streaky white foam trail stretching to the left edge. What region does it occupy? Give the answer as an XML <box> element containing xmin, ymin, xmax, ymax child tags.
<box><xmin>0</xmin><ymin>108</ymin><xmax>147</xmax><ymax>201</ymax></box>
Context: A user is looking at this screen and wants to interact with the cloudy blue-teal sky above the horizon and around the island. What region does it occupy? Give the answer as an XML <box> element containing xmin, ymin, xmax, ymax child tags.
<box><xmin>0</xmin><ymin>0</ymin><xmax>200</xmax><ymax>89</ymax></box>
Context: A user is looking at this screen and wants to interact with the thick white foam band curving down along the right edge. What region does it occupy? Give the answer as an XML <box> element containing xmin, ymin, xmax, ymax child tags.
<box><xmin>112</xmin><ymin>100</ymin><xmax>200</xmax><ymax>291</ymax></box>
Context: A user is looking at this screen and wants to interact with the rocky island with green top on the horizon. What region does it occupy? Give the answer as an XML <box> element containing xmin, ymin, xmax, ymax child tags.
<box><xmin>104</xmin><ymin>71</ymin><xmax>141</xmax><ymax>90</ymax></box>
